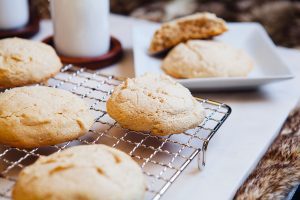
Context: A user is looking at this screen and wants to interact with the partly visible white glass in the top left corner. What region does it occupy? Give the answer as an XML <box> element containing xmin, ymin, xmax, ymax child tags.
<box><xmin>0</xmin><ymin>0</ymin><xmax>29</xmax><ymax>29</ymax></box>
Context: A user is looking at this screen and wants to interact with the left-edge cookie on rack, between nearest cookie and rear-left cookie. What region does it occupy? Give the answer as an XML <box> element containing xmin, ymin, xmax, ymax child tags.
<box><xmin>0</xmin><ymin>86</ymin><xmax>94</xmax><ymax>148</ymax></box>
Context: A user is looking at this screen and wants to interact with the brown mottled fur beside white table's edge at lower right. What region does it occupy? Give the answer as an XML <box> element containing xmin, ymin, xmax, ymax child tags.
<box><xmin>235</xmin><ymin>108</ymin><xmax>300</xmax><ymax>200</ymax></box>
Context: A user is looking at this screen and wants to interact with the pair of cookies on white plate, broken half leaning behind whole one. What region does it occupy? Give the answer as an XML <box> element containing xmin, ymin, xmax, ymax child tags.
<box><xmin>149</xmin><ymin>13</ymin><xmax>253</xmax><ymax>78</ymax></box>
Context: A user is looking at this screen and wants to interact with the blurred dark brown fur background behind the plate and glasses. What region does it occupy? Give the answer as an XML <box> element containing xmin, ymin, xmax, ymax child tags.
<box><xmin>32</xmin><ymin>0</ymin><xmax>300</xmax><ymax>49</ymax></box>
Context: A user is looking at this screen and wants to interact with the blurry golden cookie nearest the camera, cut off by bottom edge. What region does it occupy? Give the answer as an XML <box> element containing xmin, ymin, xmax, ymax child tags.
<box><xmin>12</xmin><ymin>145</ymin><xmax>145</xmax><ymax>200</ymax></box>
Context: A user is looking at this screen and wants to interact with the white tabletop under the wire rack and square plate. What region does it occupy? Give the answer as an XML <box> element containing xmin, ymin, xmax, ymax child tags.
<box><xmin>29</xmin><ymin>15</ymin><xmax>300</xmax><ymax>200</ymax></box>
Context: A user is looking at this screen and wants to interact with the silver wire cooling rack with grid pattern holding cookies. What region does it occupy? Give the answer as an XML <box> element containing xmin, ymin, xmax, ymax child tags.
<box><xmin>0</xmin><ymin>65</ymin><xmax>231</xmax><ymax>200</ymax></box>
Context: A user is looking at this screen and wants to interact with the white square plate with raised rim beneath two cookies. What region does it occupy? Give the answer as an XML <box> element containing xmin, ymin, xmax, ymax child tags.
<box><xmin>133</xmin><ymin>23</ymin><xmax>293</xmax><ymax>90</ymax></box>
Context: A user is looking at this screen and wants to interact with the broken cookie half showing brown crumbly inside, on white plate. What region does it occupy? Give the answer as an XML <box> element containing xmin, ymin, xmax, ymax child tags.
<box><xmin>149</xmin><ymin>12</ymin><xmax>228</xmax><ymax>54</ymax></box>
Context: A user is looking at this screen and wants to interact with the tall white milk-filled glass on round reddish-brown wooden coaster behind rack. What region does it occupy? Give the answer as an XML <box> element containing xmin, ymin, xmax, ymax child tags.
<box><xmin>50</xmin><ymin>0</ymin><xmax>110</xmax><ymax>57</ymax></box>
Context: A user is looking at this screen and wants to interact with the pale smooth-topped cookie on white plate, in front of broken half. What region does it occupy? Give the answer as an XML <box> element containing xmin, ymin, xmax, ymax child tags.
<box><xmin>161</xmin><ymin>40</ymin><xmax>253</xmax><ymax>78</ymax></box>
